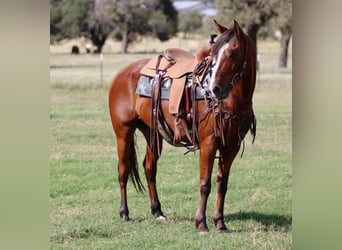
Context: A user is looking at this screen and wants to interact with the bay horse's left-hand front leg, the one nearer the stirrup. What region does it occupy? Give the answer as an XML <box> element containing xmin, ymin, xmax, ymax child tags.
<box><xmin>195</xmin><ymin>138</ymin><xmax>216</xmax><ymax>233</ymax></box>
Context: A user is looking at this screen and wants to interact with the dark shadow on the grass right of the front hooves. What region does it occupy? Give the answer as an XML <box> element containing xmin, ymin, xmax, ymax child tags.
<box><xmin>225</xmin><ymin>211</ymin><xmax>292</xmax><ymax>232</ymax></box>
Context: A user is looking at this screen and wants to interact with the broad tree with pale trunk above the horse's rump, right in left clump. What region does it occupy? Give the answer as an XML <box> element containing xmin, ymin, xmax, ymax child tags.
<box><xmin>93</xmin><ymin>0</ymin><xmax>177</xmax><ymax>53</ymax></box>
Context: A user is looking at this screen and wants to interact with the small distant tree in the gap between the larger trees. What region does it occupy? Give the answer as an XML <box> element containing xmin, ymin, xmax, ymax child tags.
<box><xmin>178</xmin><ymin>10</ymin><xmax>203</xmax><ymax>39</ymax></box>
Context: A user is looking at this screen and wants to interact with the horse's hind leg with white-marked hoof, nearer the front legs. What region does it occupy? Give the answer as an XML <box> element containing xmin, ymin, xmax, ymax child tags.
<box><xmin>140</xmin><ymin>126</ymin><xmax>166</xmax><ymax>221</ymax></box>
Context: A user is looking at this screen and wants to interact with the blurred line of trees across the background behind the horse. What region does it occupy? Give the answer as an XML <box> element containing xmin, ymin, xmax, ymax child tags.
<box><xmin>50</xmin><ymin>0</ymin><xmax>292</xmax><ymax>67</ymax></box>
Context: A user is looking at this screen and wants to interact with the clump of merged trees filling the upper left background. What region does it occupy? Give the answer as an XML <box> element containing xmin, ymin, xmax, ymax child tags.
<box><xmin>50</xmin><ymin>0</ymin><xmax>177</xmax><ymax>53</ymax></box>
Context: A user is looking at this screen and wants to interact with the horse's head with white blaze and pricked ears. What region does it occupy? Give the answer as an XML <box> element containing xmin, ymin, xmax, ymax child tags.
<box><xmin>209</xmin><ymin>20</ymin><xmax>248</xmax><ymax>99</ymax></box>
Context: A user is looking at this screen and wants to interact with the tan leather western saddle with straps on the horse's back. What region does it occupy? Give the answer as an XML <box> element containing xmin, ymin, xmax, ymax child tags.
<box><xmin>140</xmin><ymin>48</ymin><xmax>209</xmax><ymax>155</ymax></box>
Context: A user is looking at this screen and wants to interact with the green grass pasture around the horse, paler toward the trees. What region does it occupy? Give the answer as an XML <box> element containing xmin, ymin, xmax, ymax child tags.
<box><xmin>50</xmin><ymin>37</ymin><xmax>292</xmax><ymax>250</ymax></box>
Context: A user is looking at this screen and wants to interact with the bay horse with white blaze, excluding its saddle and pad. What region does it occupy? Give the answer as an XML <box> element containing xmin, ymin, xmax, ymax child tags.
<box><xmin>108</xmin><ymin>20</ymin><xmax>256</xmax><ymax>234</ymax></box>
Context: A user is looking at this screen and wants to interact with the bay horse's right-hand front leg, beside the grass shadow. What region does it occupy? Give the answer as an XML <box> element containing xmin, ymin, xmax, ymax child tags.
<box><xmin>213</xmin><ymin>146</ymin><xmax>238</xmax><ymax>232</ymax></box>
